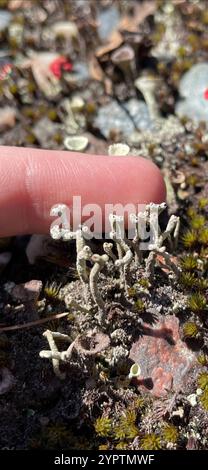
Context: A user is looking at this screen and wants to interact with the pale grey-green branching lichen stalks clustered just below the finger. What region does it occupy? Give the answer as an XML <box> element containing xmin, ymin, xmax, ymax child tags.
<box><xmin>40</xmin><ymin>203</ymin><xmax>180</xmax><ymax>378</ymax></box>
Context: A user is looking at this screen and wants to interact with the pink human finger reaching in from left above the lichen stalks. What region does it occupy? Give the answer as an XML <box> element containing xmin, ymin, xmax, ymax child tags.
<box><xmin>0</xmin><ymin>147</ymin><xmax>166</xmax><ymax>236</ymax></box>
